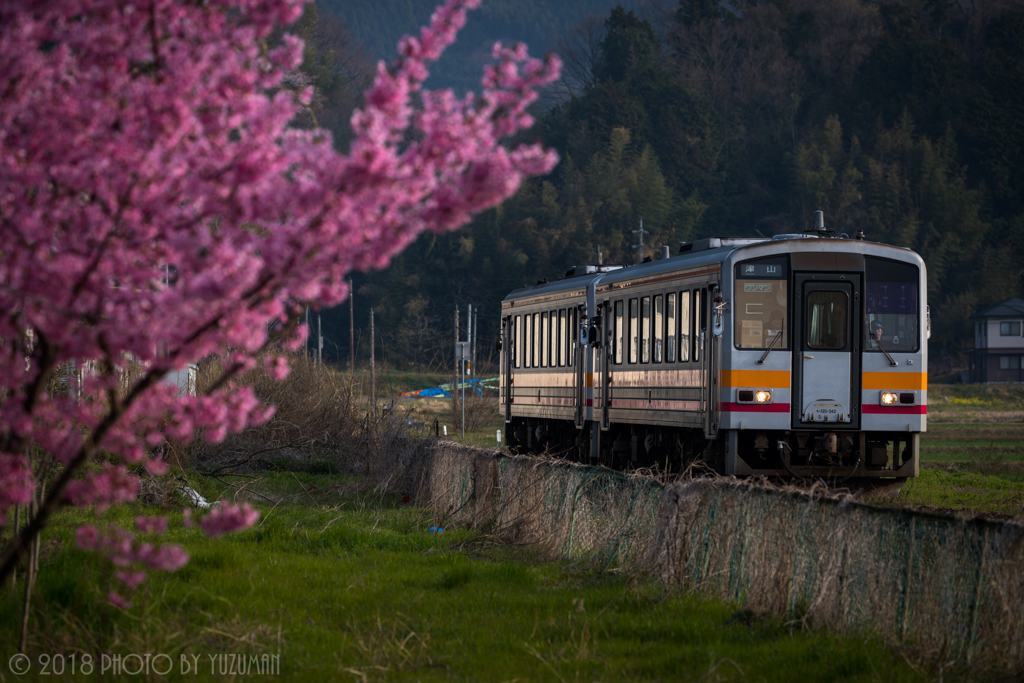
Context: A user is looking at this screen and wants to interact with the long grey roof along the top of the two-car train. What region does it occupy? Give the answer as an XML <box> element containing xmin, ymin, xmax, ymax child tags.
<box><xmin>504</xmin><ymin>233</ymin><xmax>920</xmax><ymax>301</ymax></box>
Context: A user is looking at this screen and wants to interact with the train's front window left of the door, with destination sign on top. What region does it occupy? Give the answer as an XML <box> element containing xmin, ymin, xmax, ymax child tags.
<box><xmin>733</xmin><ymin>256</ymin><xmax>790</xmax><ymax>349</ymax></box>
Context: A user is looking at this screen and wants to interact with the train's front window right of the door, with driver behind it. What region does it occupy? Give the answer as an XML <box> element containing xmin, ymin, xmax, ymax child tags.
<box><xmin>864</xmin><ymin>257</ymin><xmax>921</xmax><ymax>353</ymax></box>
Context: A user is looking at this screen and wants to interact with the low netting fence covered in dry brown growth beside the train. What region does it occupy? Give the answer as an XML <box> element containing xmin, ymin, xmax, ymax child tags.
<box><xmin>381</xmin><ymin>439</ymin><xmax>1024</xmax><ymax>673</ymax></box>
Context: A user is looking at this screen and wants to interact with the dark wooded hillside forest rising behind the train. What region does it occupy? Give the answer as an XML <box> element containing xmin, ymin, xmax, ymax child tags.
<box><xmin>301</xmin><ymin>0</ymin><xmax>1024</xmax><ymax>370</ymax></box>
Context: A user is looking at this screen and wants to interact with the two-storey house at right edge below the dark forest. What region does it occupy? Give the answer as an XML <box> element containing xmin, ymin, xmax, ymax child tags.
<box><xmin>971</xmin><ymin>297</ymin><xmax>1024</xmax><ymax>384</ymax></box>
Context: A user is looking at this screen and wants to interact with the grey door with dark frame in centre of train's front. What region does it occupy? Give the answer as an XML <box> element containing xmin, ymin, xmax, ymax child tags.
<box><xmin>793</xmin><ymin>272</ymin><xmax>861</xmax><ymax>429</ymax></box>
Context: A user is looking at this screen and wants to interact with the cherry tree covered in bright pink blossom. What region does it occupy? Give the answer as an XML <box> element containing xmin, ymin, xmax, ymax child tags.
<box><xmin>0</xmin><ymin>0</ymin><xmax>559</xmax><ymax>593</ymax></box>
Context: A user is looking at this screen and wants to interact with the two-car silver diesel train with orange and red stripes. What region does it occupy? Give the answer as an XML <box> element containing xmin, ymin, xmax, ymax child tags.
<box><xmin>498</xmin><ymin>212</ymin><xmax>931</xmax><ymax>483</ymax></box>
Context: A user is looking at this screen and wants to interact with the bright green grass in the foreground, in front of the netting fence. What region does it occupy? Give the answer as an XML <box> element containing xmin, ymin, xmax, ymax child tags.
<box><xmin>0</xmin><ymin>473</ymin><xmax>934</xmax><ymax>681</ymax></box>
